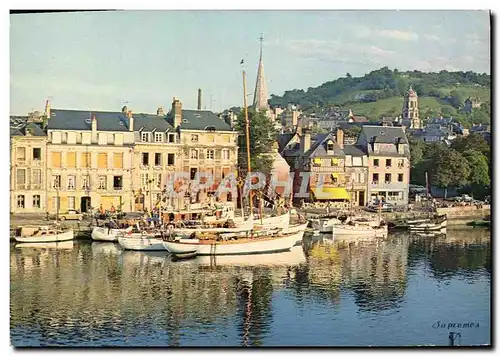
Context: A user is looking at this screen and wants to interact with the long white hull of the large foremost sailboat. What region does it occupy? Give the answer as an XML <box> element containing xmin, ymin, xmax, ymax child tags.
<box><xmin>163</xmin><ymin>224</ymin><xmax>306</xmax><ymax>255</ymax></box>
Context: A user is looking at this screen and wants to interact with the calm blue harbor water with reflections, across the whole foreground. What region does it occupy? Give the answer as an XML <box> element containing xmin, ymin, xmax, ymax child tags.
<box><xmin>10</xmin><ymin>228</ymin><xmax>491</xmax><ymax>347</ymax></box>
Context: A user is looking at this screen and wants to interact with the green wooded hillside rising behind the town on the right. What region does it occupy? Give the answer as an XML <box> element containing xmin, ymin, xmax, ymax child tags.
<box><xmin>270</xmin><ymin>67</ymin><xmax>491</xmax><ymax>126</ymax></box>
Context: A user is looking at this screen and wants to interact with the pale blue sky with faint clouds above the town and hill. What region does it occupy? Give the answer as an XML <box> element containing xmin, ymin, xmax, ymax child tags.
<box><xmin>10</xmin><ymin>10</ymin><xmax>490</xmax><ymax>115</ymax></box>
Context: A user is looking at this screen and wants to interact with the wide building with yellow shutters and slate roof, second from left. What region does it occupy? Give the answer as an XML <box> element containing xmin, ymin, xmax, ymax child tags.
<box><xmin>47</xmin><ymin>109</ymin><xmax>134</xmax><ymax>213</ymax></box>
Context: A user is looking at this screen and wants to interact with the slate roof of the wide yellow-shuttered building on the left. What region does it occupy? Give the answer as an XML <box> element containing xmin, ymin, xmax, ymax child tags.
<box><xmin>47</xmin><ymin>109</ymin><xmax>131</xmax><ymax>131</ymax></box>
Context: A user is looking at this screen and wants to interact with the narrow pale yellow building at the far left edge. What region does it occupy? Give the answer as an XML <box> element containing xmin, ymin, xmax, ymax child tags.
<box><xmin>10</xmin><ymin>123</ymin><xmax>47</xmax><ymax>213</ymax></box>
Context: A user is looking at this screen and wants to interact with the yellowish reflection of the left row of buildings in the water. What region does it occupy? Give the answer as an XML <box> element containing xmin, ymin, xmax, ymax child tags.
<box><xmin>10</xmin><ymin>243</ymin><xmax>296</xmax><ymax>345</ymax></box>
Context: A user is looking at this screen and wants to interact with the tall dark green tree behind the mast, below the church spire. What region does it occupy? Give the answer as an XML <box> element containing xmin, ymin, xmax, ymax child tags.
<box><xmin>236</xmin><ymin>108</ymin><xmax>277</xmax><ymax>174</ymax></box>
